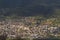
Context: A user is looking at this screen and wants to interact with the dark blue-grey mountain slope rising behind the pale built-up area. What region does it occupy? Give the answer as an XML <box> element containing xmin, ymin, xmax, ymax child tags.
<box><xmin>0</xmin><ymin>0</ymin><xmax>60</xmax><ymax>16</ymax></box>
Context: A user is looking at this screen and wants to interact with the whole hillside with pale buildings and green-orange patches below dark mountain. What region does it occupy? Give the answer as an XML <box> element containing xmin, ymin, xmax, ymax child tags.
<box><xmin>0</xmin><ymin>16</ymin><xmax>60</xmax><ymax>40</ymax></box>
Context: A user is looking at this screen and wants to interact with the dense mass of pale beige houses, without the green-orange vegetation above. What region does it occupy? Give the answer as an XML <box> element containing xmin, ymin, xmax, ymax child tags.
<box><xmin>0</xmin><ymin>19</ymin><xmax>60</xmax><ymax>38</ymax></box>
